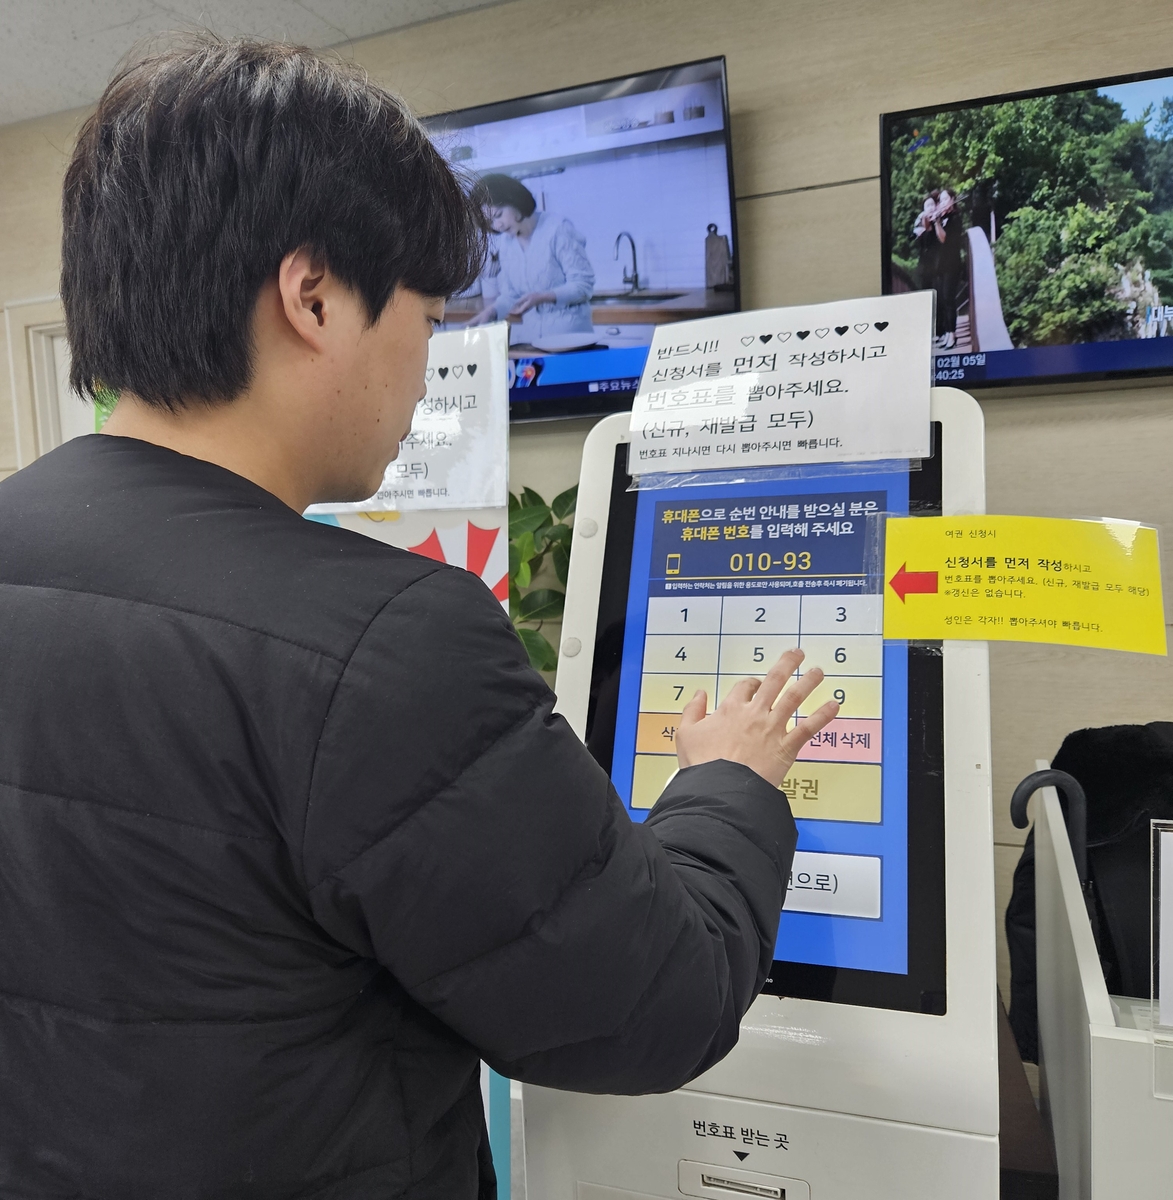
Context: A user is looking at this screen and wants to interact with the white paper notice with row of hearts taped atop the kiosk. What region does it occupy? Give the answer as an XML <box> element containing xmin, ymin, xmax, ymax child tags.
<box><xmin>627</xmin><ymin>292</ymin><xmax>933</xmax><ymax>475</ymax></box>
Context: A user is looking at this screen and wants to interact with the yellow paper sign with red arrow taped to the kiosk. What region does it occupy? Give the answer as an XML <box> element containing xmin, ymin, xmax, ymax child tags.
<box><xmin>884</xmin><ymin>516</ymin><xmax>1166</xmax><ymax>654</ymax></box>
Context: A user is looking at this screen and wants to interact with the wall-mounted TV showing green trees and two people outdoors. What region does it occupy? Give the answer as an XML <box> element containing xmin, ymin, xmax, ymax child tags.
<box><xmin>880</xmin><ymin>71</ymin><xmax>1173</xmax><ymax>386</ymax></box>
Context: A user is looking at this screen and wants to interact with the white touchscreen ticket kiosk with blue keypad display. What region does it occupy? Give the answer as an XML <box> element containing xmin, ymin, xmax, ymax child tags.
<box><xmin>525</xmin><ymin>389</ymin><xmax>998</xmax><ymax>1200</ymax></box>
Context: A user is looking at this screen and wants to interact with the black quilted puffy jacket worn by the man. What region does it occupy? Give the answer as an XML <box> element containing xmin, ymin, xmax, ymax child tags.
<box><xmin>0</xmin><ymin>436</ymin><xmax>795</xmax><ymax>1200</ymax></box>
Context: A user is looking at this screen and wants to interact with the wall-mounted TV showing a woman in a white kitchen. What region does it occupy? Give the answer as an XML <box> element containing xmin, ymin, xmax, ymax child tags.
<box><xmin>423</xmin><ymin>58</ymin><xmax>739</xmax><ymax>420</ymax></box>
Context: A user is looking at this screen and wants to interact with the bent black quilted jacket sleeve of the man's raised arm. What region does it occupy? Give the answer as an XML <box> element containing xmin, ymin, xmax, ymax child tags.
<box><xmin>302</xmin><ymin>569</ymin><xmax>796</xmax><ymax>1093</ymax></box>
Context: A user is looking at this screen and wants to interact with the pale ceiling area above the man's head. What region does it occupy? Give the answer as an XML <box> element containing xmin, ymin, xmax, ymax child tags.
<box><xmin>0</xmin><ymin>0</ymin><xmax>498</xmax><ymax>125</ymax></box>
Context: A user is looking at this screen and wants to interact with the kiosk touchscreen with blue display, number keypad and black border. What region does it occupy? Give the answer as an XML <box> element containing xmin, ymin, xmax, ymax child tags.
<box><xmin>588</xmin><ymin>427</ymin><xmax>945</xmax><ymax>1013</ymax></box>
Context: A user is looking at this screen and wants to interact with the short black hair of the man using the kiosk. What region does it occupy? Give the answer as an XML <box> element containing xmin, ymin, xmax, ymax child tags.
<box><xmin>61</xmin><ymin>37</ymin><xmax>485</xmax><ymax>410</ymax></box>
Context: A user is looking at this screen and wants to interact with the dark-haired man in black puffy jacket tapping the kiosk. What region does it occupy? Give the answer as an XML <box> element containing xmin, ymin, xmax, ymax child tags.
<box><xmin>0</xmin><ymin>41</ymin><xmax>835</xmax><ymax>1200</ymax></box>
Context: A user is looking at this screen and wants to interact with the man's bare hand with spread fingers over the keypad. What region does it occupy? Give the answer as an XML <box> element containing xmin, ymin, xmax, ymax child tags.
<box><xmin>676</xmin><ymin>650</ymin><xmax>840</xmax><ymax>787</ymax></box>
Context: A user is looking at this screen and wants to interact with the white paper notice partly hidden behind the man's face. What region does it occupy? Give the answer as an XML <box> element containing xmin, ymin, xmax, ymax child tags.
<box><xmin>307</xmin><ymin>322</ymin><xmax>509</xmax><ymax>512</ymax></box>
